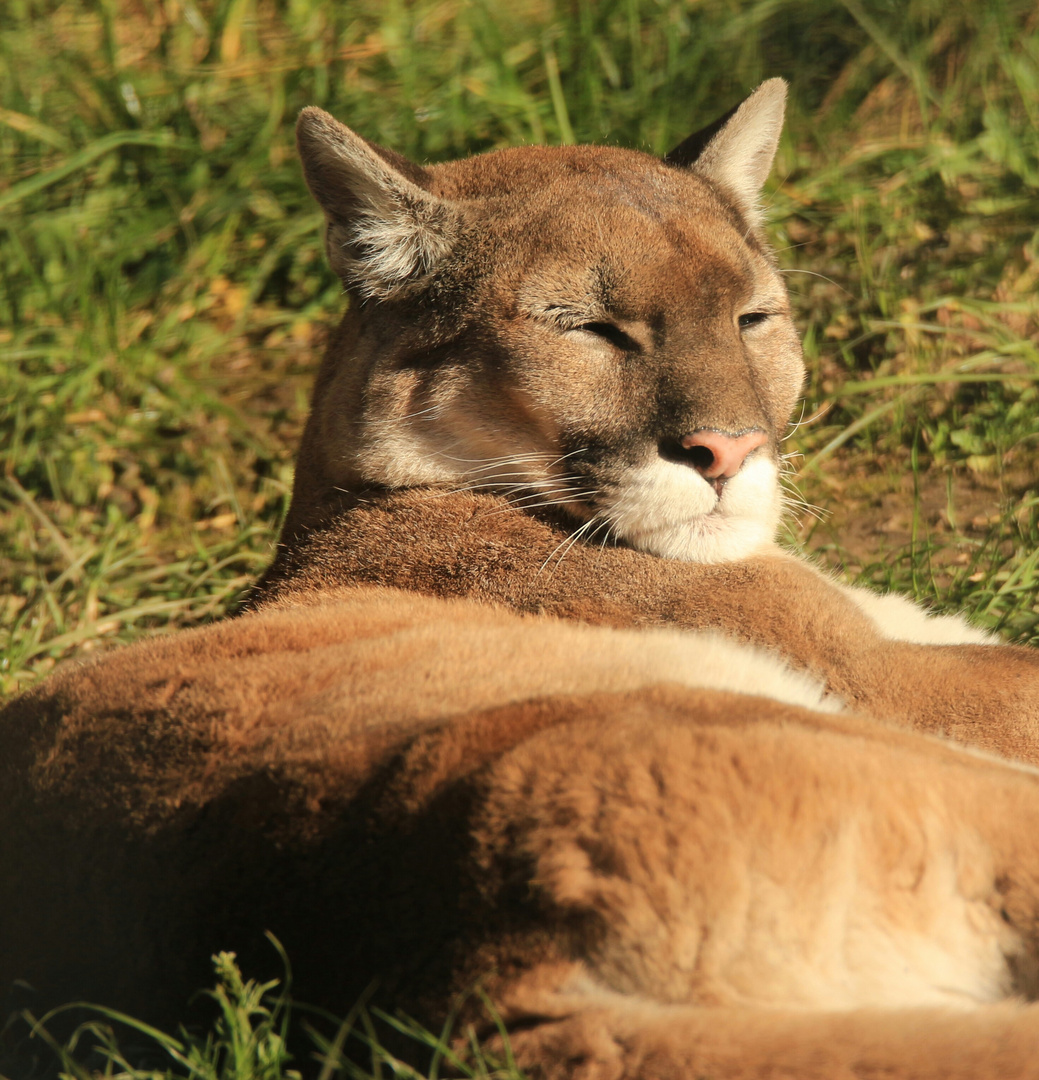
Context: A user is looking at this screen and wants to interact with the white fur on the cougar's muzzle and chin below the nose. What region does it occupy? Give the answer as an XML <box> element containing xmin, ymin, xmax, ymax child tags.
<box><xmin>599</xmin><ymin>457</ymin><xmax>781</xmax><ymax>563</ymax></box>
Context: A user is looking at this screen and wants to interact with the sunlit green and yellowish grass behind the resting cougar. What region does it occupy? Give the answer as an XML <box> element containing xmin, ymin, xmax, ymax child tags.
<box><xmin>0</xmin><ymin>0</ymin><xmax>1039</xmax><ymax>693</ymax></box>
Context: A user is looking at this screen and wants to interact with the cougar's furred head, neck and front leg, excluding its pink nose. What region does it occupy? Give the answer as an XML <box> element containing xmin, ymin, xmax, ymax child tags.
<box><xmin>261</xmin><ymin>80</ymin><xmax>1039</xmax><ymax>764</ymax></box>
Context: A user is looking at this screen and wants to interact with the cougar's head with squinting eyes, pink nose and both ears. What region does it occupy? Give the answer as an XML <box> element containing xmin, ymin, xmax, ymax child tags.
<box><xmin>294</xmin><ymin>80</ymin><xmax>804</xmax><ymax>562</ymax></box>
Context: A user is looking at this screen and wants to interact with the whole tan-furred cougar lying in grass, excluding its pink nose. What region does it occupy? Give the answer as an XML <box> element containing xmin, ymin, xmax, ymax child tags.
<box><xmin>6</xmin><ymin>81</ymin><xmax>1039</xmax><ymax>1080</ymax></box>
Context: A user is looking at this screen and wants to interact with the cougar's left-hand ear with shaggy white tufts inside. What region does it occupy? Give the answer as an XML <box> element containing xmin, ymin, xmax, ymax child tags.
<box><xmin>296</xmin><ymin>108</ymin><xmax>460</xmax><ymax>299</ymax></box>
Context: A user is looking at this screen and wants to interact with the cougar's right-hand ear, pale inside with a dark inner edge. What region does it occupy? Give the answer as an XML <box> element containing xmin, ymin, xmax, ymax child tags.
<box><xmin>664</xmin><ymin>79</ymin><xmax>786</xmax><ymax>226</ymax></box>
